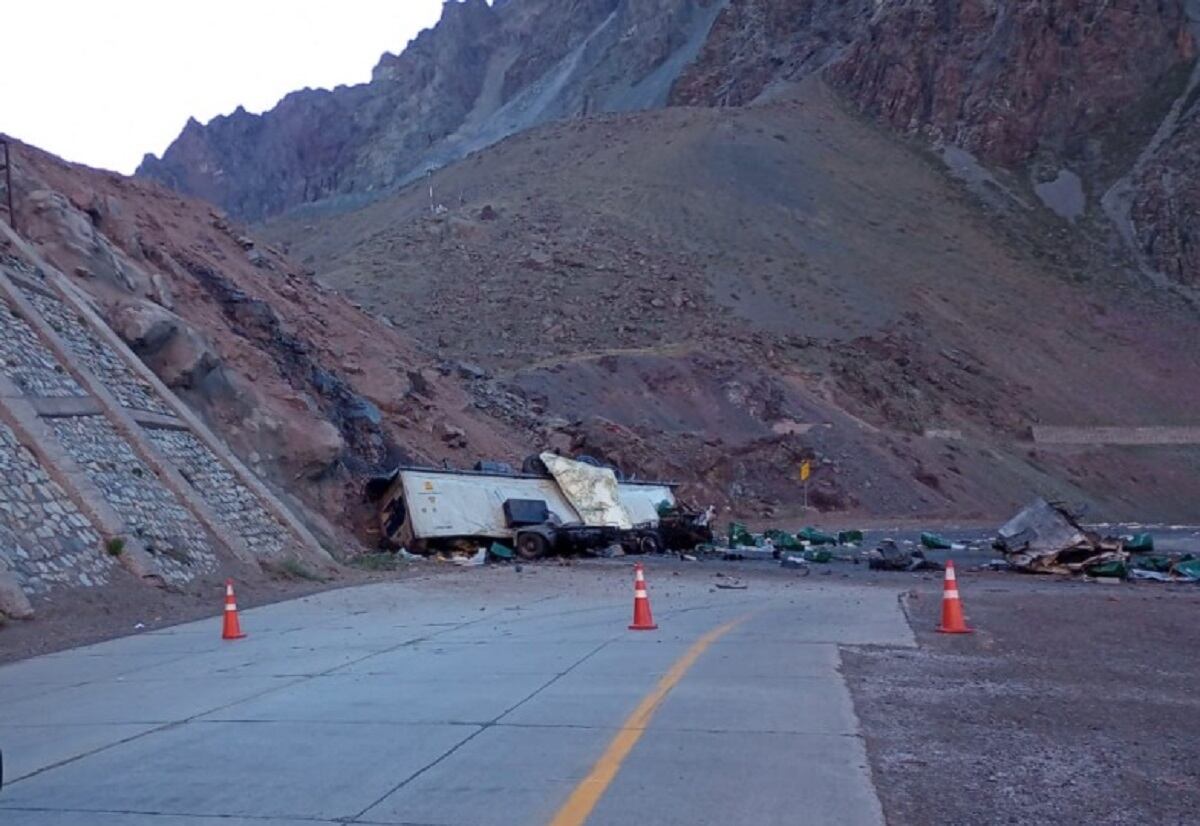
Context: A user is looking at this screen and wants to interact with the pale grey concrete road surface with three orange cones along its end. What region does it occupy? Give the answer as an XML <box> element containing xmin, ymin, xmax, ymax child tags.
<box><xmin>0</xmin><ymin>563</ymin><xmax>913</xmax><ymax>826</ymax></box>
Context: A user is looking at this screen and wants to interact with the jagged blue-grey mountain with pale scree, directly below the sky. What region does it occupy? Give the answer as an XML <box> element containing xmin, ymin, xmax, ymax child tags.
<box><xmin>139</xmin><ymin>0</ymin><xmax>722</xmax><ymax>219</ymax></box>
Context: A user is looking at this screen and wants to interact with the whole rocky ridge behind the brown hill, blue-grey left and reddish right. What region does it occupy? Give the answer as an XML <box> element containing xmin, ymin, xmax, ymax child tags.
<box><xmin>139</xmin><ymin>0</ymin><xmax>1200</xmax><ymax>286</ymax></box>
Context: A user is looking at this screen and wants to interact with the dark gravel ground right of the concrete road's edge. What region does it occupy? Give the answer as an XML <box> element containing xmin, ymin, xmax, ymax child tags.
<box><xmin>842</xmin><ymin>573</ymin><xmax>1200</xmax><ymax>825</ymax></box>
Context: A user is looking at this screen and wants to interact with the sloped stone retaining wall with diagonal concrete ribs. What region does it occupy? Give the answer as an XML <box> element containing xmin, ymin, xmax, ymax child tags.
<box><xmin>0</xmin><ymin>235</ymin><xmax>329</xmax><ymax>609</ymax></box>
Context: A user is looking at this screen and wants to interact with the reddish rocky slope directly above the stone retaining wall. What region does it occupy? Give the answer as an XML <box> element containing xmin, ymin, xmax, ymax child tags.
<box><xmin>2</xmin><ymin>135</ymin><xmax>522</xmax><ymax>551</ymax></box>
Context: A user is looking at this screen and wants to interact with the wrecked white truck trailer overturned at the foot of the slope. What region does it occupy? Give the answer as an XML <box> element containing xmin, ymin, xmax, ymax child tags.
<box><xmin>367</xmin><ymin>454</ymin><xmax>676</xmax><ymax>559</ymax></box>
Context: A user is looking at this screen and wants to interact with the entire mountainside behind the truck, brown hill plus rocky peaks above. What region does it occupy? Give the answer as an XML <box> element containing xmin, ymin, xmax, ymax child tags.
<box><xmin>131</xmin><ymin>0</ymin><xmax>1200</xmax><ymax>517</ymax></box>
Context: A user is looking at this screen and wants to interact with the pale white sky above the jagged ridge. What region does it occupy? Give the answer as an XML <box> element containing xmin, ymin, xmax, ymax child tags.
<box><xmin>0</xmin><ymin>0</ymin><xmax>442</xmax><ymax>173</ymax></box>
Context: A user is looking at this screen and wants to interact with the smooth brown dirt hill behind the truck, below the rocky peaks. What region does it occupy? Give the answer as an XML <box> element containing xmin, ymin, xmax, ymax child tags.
<box><xmin>265</xmin><ymin>82</ymin><xmax>1200</xmax><ymax>517</ymax></box>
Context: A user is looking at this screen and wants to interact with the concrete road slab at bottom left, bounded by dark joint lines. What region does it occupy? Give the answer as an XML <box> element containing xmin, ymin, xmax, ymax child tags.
<box><xmin>0</xmin><ymin>722</ymin><xmax>478</xmax><ymax>819</ymax></box>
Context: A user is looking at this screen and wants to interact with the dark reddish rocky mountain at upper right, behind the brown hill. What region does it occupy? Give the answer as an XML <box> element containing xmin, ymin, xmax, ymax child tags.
<box><xmin>671</xmin><ymin>0</ymin><xmax>1200</xmax><ymax>286</ymax></box>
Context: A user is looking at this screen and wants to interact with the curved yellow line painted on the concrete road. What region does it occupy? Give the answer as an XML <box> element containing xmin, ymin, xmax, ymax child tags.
<box><xmin>550</xmin><ymin>617</ymin><xmax>745</xmax><ymax>826</ymax></box>
